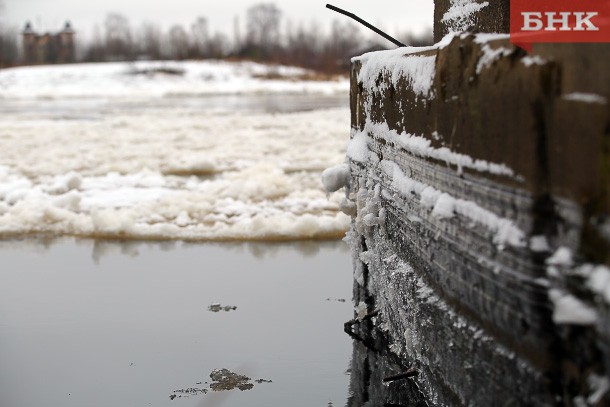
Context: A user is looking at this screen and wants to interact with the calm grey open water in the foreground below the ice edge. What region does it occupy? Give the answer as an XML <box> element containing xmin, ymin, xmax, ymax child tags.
<box><xmin>0</xmin><ymin>240</ymin><xmax>352</xmax><ymax>407</ymax></box>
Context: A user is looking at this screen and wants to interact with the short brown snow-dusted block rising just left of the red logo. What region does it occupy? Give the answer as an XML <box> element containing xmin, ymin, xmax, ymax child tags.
<box><xmin>434</xmin><ymin>0</ymin><xmax>510</xmax><ymax>42</ymax></box>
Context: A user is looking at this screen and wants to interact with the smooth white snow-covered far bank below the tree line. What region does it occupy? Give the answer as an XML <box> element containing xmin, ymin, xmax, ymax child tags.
<box><xmin>0</xmin><ymin>60</ymin><xmax>349</xmax><ymax>99</ymax></box>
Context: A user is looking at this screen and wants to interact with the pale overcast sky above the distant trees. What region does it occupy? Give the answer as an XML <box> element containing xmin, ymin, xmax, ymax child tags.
<box><xmin>0</xmin><ymin>0</ymin><xmax>434</xmax><ymax>42</ymax></box>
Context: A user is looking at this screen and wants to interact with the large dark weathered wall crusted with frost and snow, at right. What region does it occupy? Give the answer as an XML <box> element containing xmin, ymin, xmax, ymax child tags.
<box><xmin>350</xmin><ymin>35</ymin><xmax>610</xmax><ymax>405</ymax></box>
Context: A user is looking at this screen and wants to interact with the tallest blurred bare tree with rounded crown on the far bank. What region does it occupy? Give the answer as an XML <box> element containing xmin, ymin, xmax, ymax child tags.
<box><xmin>246</xmin><ymin>3</ymin><xmax>282</xmax><ymax>59</ymax></box>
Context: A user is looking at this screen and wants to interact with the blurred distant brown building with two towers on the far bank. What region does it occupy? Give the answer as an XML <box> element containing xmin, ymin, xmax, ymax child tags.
<box><xmin>21</xmin><ymin>22</ymin><xmax>75</xmax><ymax>64</ymax></box>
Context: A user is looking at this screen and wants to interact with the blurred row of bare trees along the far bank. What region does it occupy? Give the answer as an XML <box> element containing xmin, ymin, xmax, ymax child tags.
<box><xmin>0</xmin><ymin>0</ymin><xmax>432</xmax><ymax>73</ymax></box>
